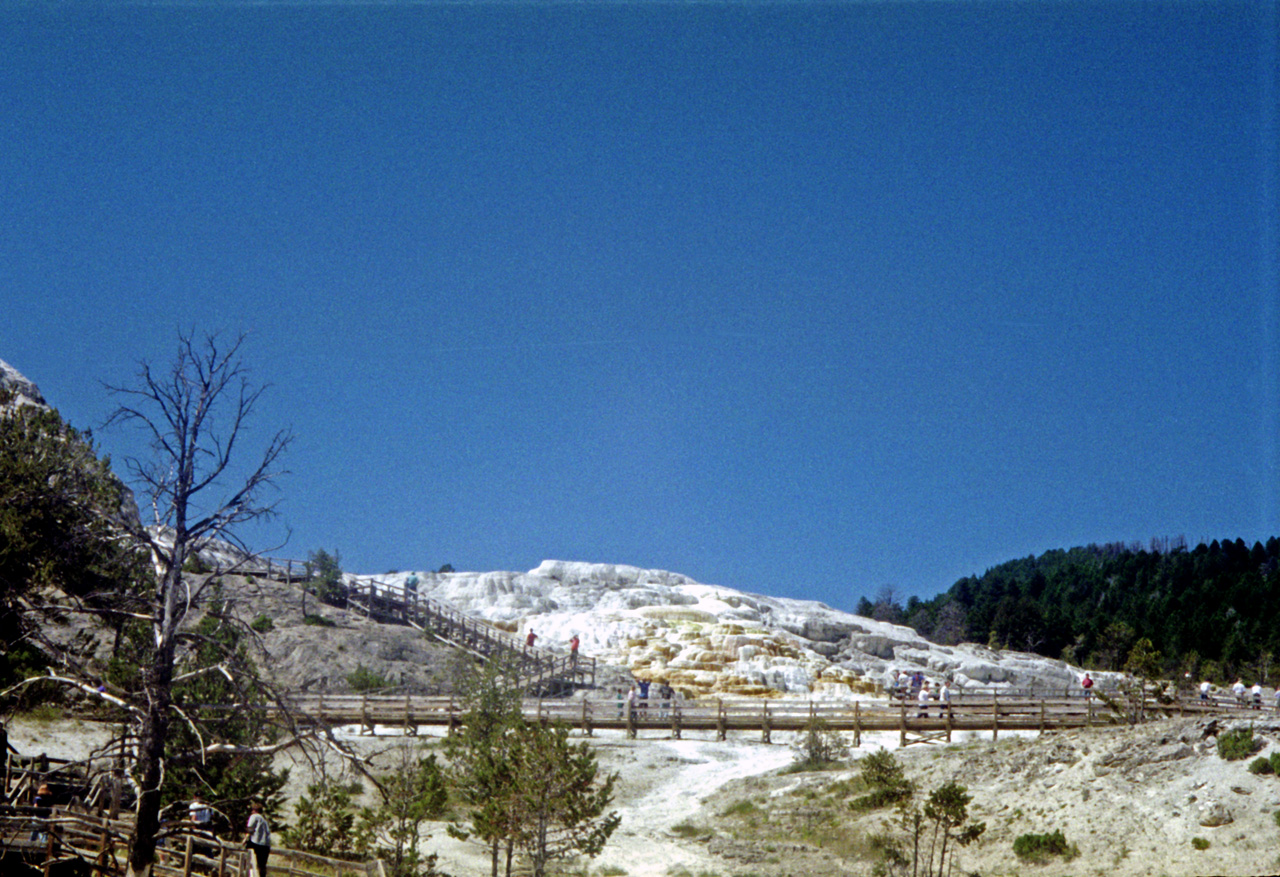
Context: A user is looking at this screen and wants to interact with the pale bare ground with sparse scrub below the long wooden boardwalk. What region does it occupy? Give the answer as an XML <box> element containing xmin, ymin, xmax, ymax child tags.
<box><xmin>10</xmin><ymin>713</ymin><xmax>1280</xmax><ymax>877</ymax></box>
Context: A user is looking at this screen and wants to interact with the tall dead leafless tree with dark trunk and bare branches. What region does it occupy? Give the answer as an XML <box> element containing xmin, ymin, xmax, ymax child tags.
<box><xmin>108</xmin><ymin>326</ymin><xmax>293</xmax><ymax>877</ymax></box>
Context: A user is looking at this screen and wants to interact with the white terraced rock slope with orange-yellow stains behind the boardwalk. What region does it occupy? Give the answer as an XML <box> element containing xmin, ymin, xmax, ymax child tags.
<box><xmin>348</xmin><ymin>561</ymin><xmax>1110</xmax><ymax>699</ymax></box>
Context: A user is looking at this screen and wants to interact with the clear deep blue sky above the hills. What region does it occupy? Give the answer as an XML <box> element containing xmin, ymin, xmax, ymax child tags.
<box><xmin>0</xmin><ymin>0</ymin><xmax>1280</xmax><ymax>608</ymax></box>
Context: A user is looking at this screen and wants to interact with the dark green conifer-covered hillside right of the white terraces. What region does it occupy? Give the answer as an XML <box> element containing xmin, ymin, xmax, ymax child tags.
<box><xmin>885</xmin><ymin>538</ymin><xmax>1280</xmax><ymax>682</ymax></box>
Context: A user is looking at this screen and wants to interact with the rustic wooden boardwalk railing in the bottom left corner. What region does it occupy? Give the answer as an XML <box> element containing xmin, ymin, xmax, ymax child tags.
<box><xmin>0</xmin><ymin>807</ymin><xmax>384</xmax><ymax>877</ymax></box>
